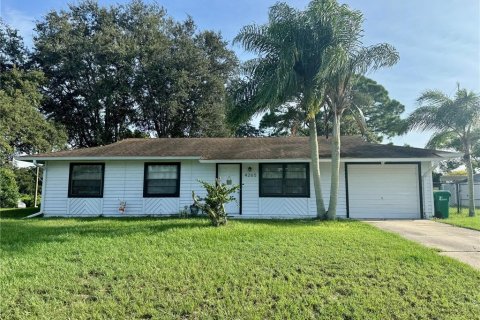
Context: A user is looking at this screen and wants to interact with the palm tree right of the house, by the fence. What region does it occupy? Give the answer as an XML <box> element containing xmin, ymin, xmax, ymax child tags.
<box><xmin>408</xmin><ymin>86</ymin><xmax>480</xmax><ymax>217</ymax></box>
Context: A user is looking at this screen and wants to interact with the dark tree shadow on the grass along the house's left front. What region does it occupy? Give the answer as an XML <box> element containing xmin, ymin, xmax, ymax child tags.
<box><xmin>0</xmin><ymin>218</ymin><xmax>210</xmax><ymax>253</ymax></box>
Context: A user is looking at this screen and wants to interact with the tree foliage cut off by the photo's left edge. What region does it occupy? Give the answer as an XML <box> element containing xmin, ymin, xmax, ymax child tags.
<box><xmin>0</xmin><ymin>23</ymin><xmax>66</xmax><ymax>164</ymax></box>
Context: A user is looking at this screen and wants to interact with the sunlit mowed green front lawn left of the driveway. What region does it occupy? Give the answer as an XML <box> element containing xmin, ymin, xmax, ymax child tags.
<box><xmin>0</xmin><ymin>219</ymin><xmax>480</xmax><ymax>319</ymax></box>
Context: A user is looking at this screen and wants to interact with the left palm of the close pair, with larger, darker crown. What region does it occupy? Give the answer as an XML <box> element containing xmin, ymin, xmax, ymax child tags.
<box><xmin>233</xmin><ymin>0</ymin><xmax>362</xmax><ymax>218</ymax></box>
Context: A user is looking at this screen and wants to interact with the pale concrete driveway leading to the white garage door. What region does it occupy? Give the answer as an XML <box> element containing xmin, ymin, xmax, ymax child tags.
<box><xmin>367</xmin><ymin>220</ymin><xmax>480</xmax><ymax>269</ymax></box>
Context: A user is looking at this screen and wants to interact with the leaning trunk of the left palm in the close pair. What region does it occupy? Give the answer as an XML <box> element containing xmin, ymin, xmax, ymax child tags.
<box><xmin>308</xmin><ymin>117</ymin><xmax>325</xmax><ymax>219</ymax></box>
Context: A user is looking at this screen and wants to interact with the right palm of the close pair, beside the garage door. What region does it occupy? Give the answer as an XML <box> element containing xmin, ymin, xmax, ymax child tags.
<box><xmin>323</xmin><ymin>45</ymin><xmax>399</xmax><ymax>219</ymax></box>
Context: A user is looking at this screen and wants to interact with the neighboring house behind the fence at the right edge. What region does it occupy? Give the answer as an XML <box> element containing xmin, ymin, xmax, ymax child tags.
<box><xmin>440</xmin><ymin>173</ymin><xmax>480</xmax><ymax>207</ymax></box>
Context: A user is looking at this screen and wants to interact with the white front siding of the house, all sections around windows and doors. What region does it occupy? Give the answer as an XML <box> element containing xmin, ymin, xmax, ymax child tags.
<box><xmin>42</xmin><ymin>160</ymin><xmax>433</xmax><ymax>218</ymax></box>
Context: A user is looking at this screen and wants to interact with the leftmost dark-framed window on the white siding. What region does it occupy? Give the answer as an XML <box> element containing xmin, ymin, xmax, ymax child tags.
<box><xmin>68</xmin><ymin>163</ymin><xmax>105</xmax><ymax>198</ymax></box>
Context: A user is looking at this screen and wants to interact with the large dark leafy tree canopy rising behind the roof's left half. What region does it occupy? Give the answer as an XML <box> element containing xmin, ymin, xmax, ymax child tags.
<box><xmin>33</xmin><ymin>1</ymin><xmax>237</xmax><ymax>147</ymax></box>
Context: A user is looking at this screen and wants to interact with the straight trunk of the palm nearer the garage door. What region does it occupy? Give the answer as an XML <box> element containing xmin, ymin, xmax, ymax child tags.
<box><xmin>327</xmin><ymin>112</ymin><xmax>340</xmax><ymax>220</ymax></box>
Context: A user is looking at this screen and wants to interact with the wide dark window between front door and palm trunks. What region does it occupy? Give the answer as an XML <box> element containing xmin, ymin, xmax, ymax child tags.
<box><xmin>260</xmin><ymin>163</ymin><xmax>310</xmax><ymax>197</ymax></box>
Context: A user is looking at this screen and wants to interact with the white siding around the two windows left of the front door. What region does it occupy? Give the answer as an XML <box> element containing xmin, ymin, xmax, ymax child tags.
<box><xmin>42</xmin><ymin>160</ymin><xmax>215</xmax><ymax>216</ymax></box>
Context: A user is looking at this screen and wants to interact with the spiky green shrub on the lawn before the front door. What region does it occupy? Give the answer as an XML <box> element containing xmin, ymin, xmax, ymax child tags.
<box><xmin>192</xmin><ymin>179</ymin><xmax>240</xmax><ymax>227</ymax></box>
